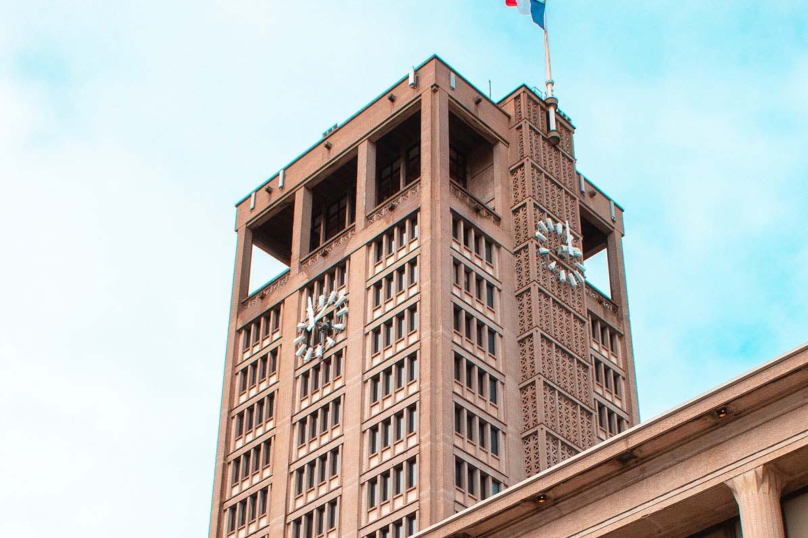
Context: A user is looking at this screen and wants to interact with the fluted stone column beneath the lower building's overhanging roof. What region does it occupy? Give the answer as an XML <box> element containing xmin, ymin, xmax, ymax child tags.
<box><xmin>726</xmin><ymin>465</ymin><xmax>786</xmax><ymax>538</ymax></box>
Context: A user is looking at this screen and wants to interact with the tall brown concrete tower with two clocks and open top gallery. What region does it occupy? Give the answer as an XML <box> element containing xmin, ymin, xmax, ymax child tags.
<box><xmin>210</xmin><ymin>57</ymin><xmax>638</xmax><ymax>538</ymax></box>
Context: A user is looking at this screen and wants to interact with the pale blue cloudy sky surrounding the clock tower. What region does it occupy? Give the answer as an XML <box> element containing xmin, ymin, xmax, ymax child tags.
<box><xmin>0</xmin><ymin>0</ymin><xmax>808</xmax><ymax>538</ymax></box>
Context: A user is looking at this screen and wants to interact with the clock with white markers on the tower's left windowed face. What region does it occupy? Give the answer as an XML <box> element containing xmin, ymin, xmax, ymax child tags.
<box><xmin>294</xmin><ymin>291</ymin><xmax>348</xmax><ymax>362</ymax></box>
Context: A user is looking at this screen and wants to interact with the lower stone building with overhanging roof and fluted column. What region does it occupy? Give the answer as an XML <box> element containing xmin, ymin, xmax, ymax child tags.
<box><xmin>419</xmin><ymin>345</ymin><xmax>808</xmax><ymax>538</ymax></box>
